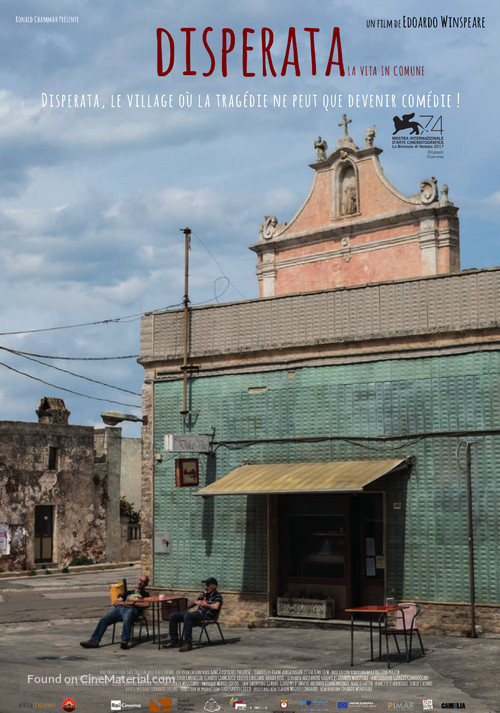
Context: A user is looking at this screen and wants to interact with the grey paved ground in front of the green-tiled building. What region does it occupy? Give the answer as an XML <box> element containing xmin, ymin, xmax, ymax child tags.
<box><xmin>0</xmin><ymin>576</ymin><xmax>500</xmax><ymax>713</ymax></box>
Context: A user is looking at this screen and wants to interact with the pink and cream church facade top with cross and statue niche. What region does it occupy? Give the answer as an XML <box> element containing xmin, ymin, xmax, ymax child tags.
<box><xmin>252</xmin><ymin>115</ymin><xmax>460</xmax><ymax>297</ymax></box>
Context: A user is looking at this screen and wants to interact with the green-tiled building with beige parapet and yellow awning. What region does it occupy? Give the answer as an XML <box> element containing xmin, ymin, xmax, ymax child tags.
<box><xmin>140</xmin><ymin>124</ymin><xmax>500</xmax><ymax>633</ymax></box>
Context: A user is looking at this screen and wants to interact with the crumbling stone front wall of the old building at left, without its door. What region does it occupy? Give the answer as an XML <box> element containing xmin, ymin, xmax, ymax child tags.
<box><xmin>0</xmin><ymin>421</ymin><xmax>108</xmax><ymax>569</ymax></box>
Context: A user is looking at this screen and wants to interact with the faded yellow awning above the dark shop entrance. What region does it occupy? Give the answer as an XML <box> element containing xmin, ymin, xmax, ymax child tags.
<box><xmin>195</xmin><ymin>458</ymin><xmax>407</xmax><ymax>497</ymax></box>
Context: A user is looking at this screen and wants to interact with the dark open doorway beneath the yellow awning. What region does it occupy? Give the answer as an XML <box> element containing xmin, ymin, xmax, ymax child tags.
<box><xmin>276</xmin><ymin>493</ymin><xmax>385</xmax><ymax>618</ymax></box>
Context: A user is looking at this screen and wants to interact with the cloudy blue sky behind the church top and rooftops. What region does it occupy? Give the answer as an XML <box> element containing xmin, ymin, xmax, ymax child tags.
<box><xmin>0</xmin><ymin>0</ymin><xmax>500</xmax><ymax>435</ymax></box>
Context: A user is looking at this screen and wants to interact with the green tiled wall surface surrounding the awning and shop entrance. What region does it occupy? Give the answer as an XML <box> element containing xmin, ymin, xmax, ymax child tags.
<box><xmin>154</xmin><ymin>352</ymin><xmax>500</xmax><ymax>603</ymax></box>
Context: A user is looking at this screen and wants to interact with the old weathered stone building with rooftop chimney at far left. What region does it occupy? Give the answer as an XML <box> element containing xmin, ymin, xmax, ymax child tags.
<box><xmin>0</xmin><ymin>397</ymin><xmax>140</xmax><ymax>569</ymax></box>
